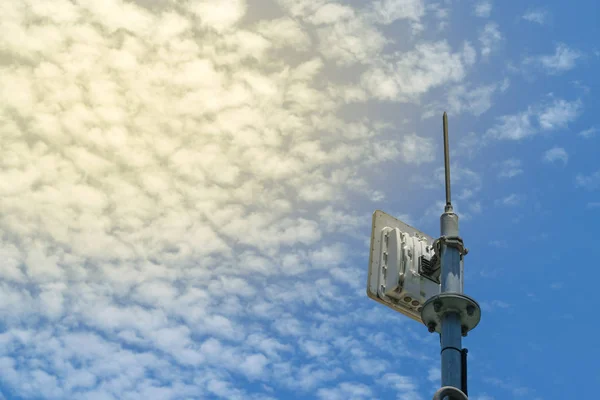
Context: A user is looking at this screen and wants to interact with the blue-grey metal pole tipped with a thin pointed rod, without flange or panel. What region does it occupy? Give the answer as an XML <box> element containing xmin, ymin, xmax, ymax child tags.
<box><xmin>440</xmin><ymin>113</ymin><xmax>463</xmax><ymax>396</ymax></box>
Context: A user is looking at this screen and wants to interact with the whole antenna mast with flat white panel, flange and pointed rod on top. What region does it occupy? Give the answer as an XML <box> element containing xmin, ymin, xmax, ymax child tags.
<box><xmin>367</xmin><ymin>112</ymin><xmax>481</xmax><ymax>400</ymax></box>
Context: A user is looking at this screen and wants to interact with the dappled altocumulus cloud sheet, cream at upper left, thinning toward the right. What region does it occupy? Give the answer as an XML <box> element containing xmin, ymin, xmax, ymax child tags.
<box><xmin>0</xmin><ymin>0</ymin><xmax>592</xmax><ymax>400</ymax></box>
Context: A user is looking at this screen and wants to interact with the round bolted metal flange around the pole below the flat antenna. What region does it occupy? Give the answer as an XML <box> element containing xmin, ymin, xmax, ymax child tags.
<box><xmin>421</xmin><ymin>293</ymin><xmax>481</xmax><ymax>336</ymax></box>
